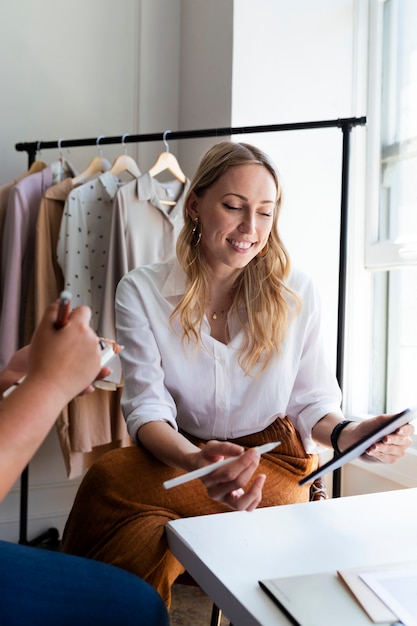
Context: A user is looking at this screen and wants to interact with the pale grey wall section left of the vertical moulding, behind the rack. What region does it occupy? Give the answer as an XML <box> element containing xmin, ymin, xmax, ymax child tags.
<box><xmin>0</xmin><ymin>0</ymin><xmax>141</xmax><ymax>184</ymax></box>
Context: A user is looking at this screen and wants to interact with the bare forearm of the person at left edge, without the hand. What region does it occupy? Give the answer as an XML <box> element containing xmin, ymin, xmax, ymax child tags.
<box><xmin>0</xmin><ymin>378</ymin><xmax>68</xmax><ymax>501</ymax></box>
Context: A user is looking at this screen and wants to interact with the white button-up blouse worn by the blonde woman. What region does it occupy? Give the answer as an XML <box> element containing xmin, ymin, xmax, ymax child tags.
<box><xmin>116</xmin><ymin>261</ymin><xmax>342</xmax><ymax>453</ymax></box>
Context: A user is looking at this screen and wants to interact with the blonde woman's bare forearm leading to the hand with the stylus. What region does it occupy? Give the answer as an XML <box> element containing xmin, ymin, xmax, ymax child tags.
<box><xmin>137</xmin><ymin>421</ymin><xmax>200</xmax><ymax>471</ymax></box>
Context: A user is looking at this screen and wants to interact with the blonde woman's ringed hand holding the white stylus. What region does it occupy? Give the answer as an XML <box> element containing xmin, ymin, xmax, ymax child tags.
<box><xmin>200</xmin><ymin>441</ymin><xmax>266</xmax><ymax>511</ymax></box>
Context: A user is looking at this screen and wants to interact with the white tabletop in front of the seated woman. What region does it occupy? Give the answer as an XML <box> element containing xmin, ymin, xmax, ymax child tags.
<box><xmin>167</xmin><ymin>488</ymin><xmax>417</xmax><ymax>626</ymax></box>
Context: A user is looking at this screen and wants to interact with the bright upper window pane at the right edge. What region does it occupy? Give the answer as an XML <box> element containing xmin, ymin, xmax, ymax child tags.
<box><xmin>378</xmin><ymin>0</ymin><xmax>417</xmax><ymax>249</ymax></box>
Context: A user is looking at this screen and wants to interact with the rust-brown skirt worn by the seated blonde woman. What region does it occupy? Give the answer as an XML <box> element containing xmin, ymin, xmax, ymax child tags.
<box><xmin>63</xmin><ymin>418</ymin><xmax>318</xmax><ymax>606</ymax></box>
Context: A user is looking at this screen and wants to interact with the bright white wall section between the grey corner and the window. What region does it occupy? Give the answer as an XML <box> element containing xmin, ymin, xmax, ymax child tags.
<box><xmin>229</xmin><ymin>0</ymin><xmax>356</xmax><ymax>359</ymax></box>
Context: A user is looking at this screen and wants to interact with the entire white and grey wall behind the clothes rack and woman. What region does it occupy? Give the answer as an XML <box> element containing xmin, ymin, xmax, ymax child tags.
<box><xmin>0</xmin><ymin>0</ymin><xmax>394</xmax><ymax>540</ymax></box>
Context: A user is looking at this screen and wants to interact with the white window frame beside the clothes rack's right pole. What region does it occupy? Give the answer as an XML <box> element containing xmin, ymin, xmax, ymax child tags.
<box><xmin>344</xmin><ymin>0</ymin><xmax>417</xmax><ymax>487</ymax></box>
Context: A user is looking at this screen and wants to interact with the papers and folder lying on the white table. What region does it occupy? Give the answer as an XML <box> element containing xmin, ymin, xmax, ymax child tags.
<box><xmin>259</xmin><ymin>561</ymin><xmax>417</xmax><ymax>626</ymax></box>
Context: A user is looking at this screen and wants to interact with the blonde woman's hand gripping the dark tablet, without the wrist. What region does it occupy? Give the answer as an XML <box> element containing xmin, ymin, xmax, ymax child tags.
<box><xmin>339</xmin><ymin>415</ymin><xmax>414</xmax><ymax>464</ymax></box>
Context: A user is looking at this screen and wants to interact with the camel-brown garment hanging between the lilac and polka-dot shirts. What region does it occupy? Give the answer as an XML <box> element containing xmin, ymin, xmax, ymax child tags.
<box><xmin>26</xmin><ymin>178</ymin><xmax>130</xmax><ymax>478</ymax></box>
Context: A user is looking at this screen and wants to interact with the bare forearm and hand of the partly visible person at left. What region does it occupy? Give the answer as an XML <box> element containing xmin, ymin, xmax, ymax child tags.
<box><xmin>0</xmin><ymin>304</ymin><xmax>103</xmax><ymax>500</ymax></box>
